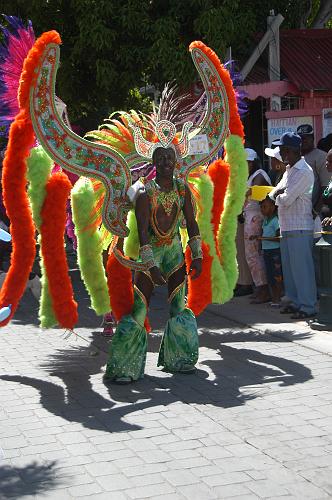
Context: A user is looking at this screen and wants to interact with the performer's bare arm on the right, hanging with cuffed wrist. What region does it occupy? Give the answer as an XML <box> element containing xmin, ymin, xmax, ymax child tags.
<box><xmin>183</xmin><ymin>186</ymin><xmax>203</xmax><ymax>279</ymax></box>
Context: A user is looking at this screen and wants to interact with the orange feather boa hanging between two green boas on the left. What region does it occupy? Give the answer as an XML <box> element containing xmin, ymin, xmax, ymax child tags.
<box><xmin>40</xmin><ymin>172</ymin><xmax>78</xmax><ymax>330</ymax></box>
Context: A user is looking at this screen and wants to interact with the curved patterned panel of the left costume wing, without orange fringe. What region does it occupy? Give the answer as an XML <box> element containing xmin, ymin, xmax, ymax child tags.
<box><xmin>30</xmin><ymin>43</ymin><xmax>131</xmax><ymax>237</ymax></box>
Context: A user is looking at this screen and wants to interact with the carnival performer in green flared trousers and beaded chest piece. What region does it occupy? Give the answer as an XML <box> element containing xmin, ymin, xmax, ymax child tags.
<box><xmin>106</xmin><ymin>148</ymin><xmax>203</xmax><ymax>383</ymax></box>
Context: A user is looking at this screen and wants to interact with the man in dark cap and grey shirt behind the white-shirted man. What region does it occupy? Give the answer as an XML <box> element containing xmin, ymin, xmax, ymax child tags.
<box><xmin>297</xmin><ymin>124</ymin><xmax>330</xmax><ymax>213</ymax></box>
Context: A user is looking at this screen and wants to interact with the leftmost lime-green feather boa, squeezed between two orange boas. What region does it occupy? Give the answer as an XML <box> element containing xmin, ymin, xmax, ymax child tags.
<box><xmin>27</xmin><ymin>146</ymin><xmax>57</xmax><ymax>328</ymax></box>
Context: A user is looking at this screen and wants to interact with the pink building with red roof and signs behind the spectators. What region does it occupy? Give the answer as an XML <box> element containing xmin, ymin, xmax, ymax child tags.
<box><xmin>241</xmin><ymin>29</ymin><xmax>332</xmax><ymax>164</ymax></box>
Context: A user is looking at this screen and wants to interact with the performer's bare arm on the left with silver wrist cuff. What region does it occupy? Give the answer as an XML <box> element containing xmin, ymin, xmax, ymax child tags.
<box><xmin>135</xmin><ymin>192</ymin><xmax>166</xmax><ymax>285</ymax></box>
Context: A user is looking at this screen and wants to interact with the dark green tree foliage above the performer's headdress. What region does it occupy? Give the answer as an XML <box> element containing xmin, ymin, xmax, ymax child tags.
<box><xmin>0</xmin><ymin>0</ymin><xmax>332</xmax><ymax>128</ymax></box>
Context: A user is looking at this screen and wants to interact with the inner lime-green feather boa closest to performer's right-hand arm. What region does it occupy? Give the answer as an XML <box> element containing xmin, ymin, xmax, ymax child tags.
<box><xmin>190</xmin><ymin>174</ymin><xmax>227</xmax><ymax>304</ymax></box>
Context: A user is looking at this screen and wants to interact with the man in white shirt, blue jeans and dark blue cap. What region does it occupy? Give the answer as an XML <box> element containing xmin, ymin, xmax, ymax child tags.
<box><xmin>269</xmin><ymin>132</ymin><xmax>317</xmax><ymax>320</ymax></box>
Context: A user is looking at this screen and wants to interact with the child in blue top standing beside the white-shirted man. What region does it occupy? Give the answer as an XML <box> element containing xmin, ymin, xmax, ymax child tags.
<box><xmin>249</xmin><ymin>196</ymin><xmax>283</xmax><ymax>307</ymax></box>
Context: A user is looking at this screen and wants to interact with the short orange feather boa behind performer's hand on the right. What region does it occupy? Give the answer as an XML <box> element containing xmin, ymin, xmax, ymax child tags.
<box><xmin>185</xmin><ymin>242</ymin><xmax>213</xmax><ymax>316</ymax></box>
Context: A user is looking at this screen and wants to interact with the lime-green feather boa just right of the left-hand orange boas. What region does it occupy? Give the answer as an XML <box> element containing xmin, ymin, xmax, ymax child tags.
<box><xmin>71</xmin><ymin>177</ymin><xmax>111</xmax><ymax>315</ymax></box>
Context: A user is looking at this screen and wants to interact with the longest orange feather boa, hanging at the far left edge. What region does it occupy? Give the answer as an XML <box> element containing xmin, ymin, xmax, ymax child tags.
<box><xmin>0</xmin><ymin>111</ymin><xmax>36</xmax><ymax>326</ymax></box>
